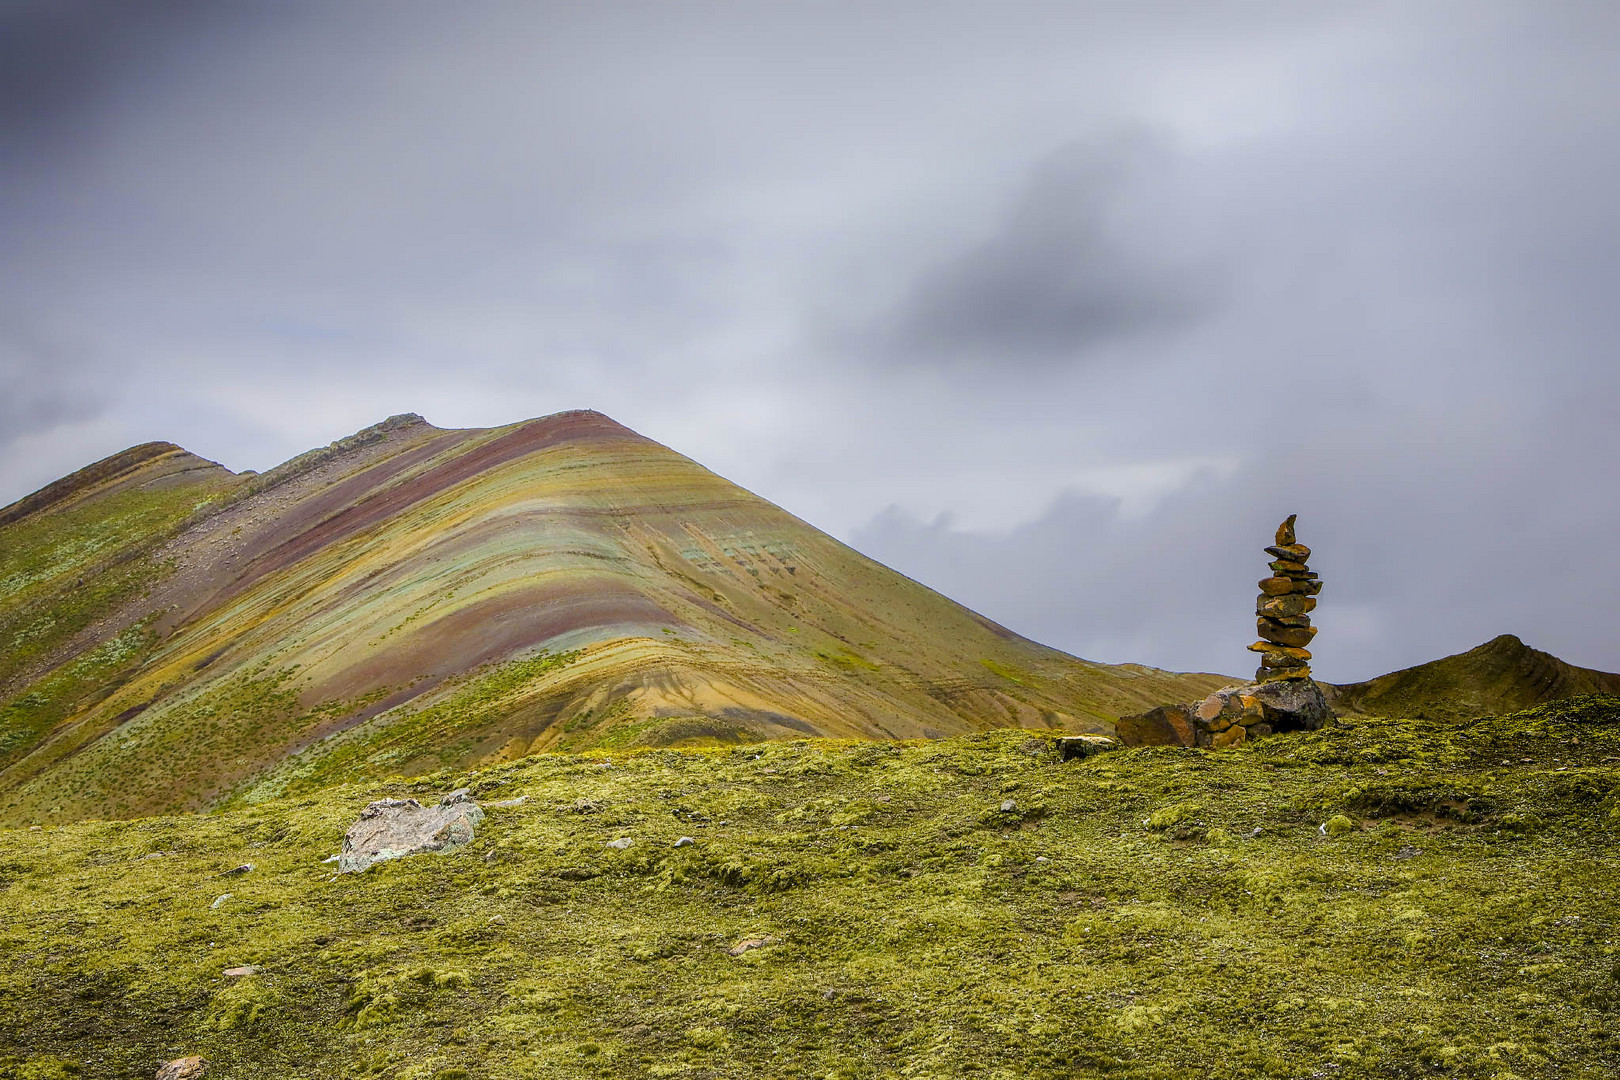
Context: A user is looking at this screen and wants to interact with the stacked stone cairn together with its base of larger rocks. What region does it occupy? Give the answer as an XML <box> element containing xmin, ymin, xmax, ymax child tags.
<box><xmin>1115</xmin><ymin>515</ymin><xmax>1333</xmax><ymax>746</ymax></box>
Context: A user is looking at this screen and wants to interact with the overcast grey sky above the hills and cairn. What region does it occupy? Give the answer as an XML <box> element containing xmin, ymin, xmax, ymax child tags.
<box><xmin>0</xmin><ymin>0</ymin><xmax>1620</xmax><ymax>682</ymax></box>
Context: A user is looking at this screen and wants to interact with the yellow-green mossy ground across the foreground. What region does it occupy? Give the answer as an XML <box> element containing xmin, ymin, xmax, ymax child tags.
<box><xmin>0</xmin><ymin>698</ymin><xmax>1620</xmax><ymax>1080</ymax></box>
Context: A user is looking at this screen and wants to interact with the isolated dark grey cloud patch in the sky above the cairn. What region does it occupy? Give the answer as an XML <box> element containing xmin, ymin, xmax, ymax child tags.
<box><xmin>881</xmin><ymin>133</ymin><xmax>1213</xmax><ymax>364</ymax></box>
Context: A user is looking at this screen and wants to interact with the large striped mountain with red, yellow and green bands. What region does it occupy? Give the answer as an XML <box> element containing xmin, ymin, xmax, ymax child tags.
<box><xmin>0</xmin><ymin>411</ymin><xmax>1228</xmax><ymax>821</ymax></box>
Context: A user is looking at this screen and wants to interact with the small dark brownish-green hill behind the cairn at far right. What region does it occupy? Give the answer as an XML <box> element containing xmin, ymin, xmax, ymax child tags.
<box><xmin>1324</xmin><ymin>633</ymin><xmax>1620</xmax><ymax>719</ymax></box>
